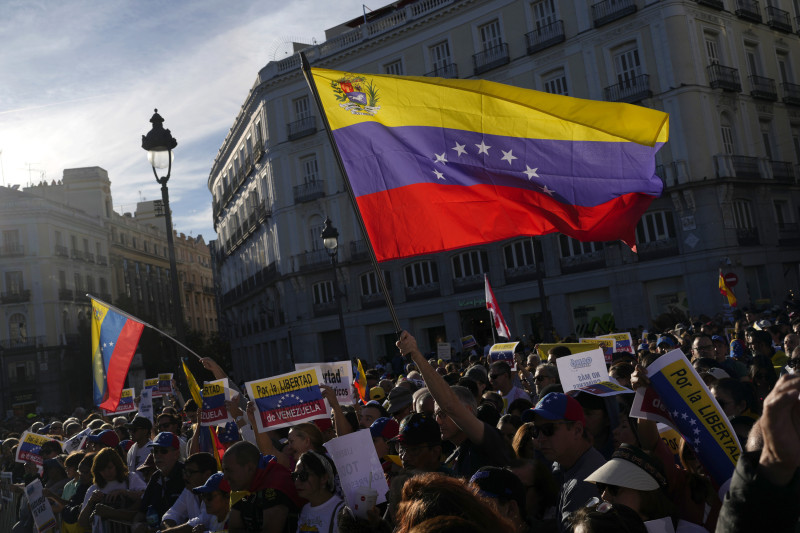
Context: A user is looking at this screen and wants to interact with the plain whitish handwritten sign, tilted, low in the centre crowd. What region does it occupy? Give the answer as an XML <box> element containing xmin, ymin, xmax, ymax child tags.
<box><xmin>324</xmin><ymin>429</ymin><xmax>389</xmax><ymax>508</ymax></box>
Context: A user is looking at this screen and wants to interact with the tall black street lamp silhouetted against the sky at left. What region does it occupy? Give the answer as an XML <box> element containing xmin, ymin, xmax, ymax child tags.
<box><xmin>142</xmin><ymin>109</ymin><xmax>185</xmax><ymax>342</ymax></box>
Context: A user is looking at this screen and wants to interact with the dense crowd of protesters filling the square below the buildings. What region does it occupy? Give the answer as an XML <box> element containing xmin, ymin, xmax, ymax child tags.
<box><xmin>0</xmin><ymin>311</ymin><xmax>800</xmax><ymax>533</ymax></box>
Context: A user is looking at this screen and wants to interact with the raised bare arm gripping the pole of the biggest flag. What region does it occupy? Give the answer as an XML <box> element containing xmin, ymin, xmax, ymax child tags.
<box><xmin>397</xmin><ymin>331</ymin><xmax>484</xmax><ymax>444</ymax></box>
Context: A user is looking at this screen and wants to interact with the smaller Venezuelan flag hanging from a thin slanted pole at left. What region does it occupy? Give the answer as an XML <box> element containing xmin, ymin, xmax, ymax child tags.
<box><xmin>92</xmin><ymin>299</ymin><xmax>144</xmax><ymax>411</ymax></box>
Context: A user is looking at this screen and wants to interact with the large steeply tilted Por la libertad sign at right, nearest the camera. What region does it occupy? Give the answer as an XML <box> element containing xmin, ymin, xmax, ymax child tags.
<box><xmin>631</xmin><ymin>350</ymin><xmax>741</xmax><ymax>486</ymax></box>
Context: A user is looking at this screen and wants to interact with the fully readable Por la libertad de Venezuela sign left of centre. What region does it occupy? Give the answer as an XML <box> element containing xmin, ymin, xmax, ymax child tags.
<box><xmin>245</xmin><ymin>366</ymin><xmax>328</xmax><ymax>432</ymax></box>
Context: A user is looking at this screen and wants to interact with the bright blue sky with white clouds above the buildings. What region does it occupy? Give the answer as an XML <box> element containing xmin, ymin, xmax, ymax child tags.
<box><xmin>0</xmin><ymin>0</ymin><xmax>366</xmax><ymax>242</ymax></box>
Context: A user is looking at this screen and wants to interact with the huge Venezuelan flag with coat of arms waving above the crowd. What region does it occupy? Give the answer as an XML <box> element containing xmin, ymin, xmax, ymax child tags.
<box><xmin>311</xmin><ymin>69</ymin><xmax>668</xmax><ymax>261</ymax></box>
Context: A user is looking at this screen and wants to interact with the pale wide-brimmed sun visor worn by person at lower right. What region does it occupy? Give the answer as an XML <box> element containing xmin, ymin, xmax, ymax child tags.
<box><xmin>586</xmin><ymin>444</ymin><xmax>667</xmax><ymax>490</ymax></box>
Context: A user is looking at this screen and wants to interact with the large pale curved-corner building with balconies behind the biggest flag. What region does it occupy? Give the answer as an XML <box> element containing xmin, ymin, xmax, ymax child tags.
<box><xmin>208</xmin><ymin>0</ymin><xmax>800</xmax><ymax>375</ymax></box>
